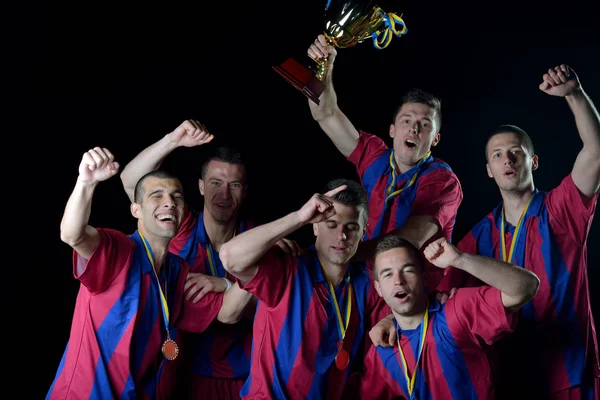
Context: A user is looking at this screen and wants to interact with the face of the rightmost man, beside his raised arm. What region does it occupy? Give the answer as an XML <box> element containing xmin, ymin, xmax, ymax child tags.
<box><xmin>486</xmin><ymin>132</ymin><xmax>538</xmax><ymax>192</ymax></box>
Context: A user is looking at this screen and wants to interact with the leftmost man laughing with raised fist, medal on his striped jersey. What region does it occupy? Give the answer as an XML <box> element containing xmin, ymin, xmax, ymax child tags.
<box><xmin>46</xmin><ymin>147</ymin><xmax>220</xmax><ymax>400</ymax></box>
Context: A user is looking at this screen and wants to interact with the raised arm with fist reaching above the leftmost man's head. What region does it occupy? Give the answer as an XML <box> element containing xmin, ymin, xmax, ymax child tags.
<box><xmin>121</xmin><ymin>120</ymin><xmax>214</xmax><ymax>201</ymax></box>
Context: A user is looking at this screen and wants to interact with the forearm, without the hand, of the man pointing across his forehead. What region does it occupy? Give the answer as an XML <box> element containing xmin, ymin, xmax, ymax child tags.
<box><xmin>219</xmin><ymin>212</ymin><xmax>305</xmax><ymax>278</ymax></box>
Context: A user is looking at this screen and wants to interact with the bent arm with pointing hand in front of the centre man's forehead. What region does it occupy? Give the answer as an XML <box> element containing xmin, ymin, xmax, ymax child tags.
<box><xmin>219</xmin><ymin>185</ymin><xmax>346</xmax><ymax>284</ymax></box>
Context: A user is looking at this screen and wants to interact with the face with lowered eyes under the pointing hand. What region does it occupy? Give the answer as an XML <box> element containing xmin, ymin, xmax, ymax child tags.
<box><xmin>313</xmin><ymin>201</ymin><xmax>366</xmax><ymax>265</ymax></box>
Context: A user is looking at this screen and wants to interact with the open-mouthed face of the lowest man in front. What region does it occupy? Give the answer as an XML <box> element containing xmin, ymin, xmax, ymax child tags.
<box><xmin>375</xmin><ymin>247</ymin><xmax>427</xmax><ymax>316</ymax></box>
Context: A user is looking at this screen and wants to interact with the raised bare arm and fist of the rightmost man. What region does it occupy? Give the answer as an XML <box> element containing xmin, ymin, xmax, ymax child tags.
<box><xmin>540</xmin><ymin>64</ymin><xmax>600</xmax><ymax>197</ymax></box>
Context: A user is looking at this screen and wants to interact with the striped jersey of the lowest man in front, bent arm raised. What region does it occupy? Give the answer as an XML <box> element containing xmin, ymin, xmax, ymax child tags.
<box><xmin>360</xmin><ymin>286</ymin><xmax>517</xmax><ymax>400</ymax></box>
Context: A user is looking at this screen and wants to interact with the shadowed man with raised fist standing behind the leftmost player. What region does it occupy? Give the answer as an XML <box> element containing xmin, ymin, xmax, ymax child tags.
<box><xmin>121</xmin><ymin>120</ymin><xmax>255</xmax><ymax>399</ymax></box>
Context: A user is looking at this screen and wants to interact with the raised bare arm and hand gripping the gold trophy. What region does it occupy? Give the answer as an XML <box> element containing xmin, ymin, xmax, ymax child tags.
<box><xmin>308</xmin><ymin>35</ymin><xmax>359</xmax><ymax>157</ymax></box>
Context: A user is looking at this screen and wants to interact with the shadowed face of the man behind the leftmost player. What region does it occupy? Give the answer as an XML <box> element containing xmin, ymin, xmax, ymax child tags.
<box><xmin>200</xmin><ymin>160</ymin><xmax>246</xmax><ymax>223</ymax></box>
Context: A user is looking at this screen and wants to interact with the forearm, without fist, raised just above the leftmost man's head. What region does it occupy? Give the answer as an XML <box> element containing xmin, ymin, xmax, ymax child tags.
<box><xmin>121</xmin><ymin>134</ymin><xmax>177</xmax><ymax>201</ymax></box>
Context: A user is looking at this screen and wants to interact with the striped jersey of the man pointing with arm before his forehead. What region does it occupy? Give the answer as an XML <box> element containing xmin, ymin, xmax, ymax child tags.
<box><xmin>240</xmin><ymin>246</ymin><xmax>391</xmax><ymax>400</ymax></box>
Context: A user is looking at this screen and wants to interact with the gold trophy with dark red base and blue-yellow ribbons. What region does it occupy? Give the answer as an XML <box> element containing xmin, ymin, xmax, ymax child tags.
<box><xmin>273</xmin><ymin>0</ymin><xmax>407</xmax><ymax>104</ymax></box>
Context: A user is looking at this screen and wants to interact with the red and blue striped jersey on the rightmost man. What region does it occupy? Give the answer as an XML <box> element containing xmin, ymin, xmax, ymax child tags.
<box><xmin>440</xmin><ymin>175</ymin><xmax>600</xmax><ymax>396</ymax></box>
